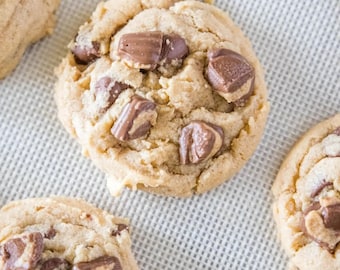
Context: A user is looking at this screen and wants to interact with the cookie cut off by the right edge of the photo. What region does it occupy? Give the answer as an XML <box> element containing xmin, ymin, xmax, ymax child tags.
<box><xmin>273</xmin><ymin>114</ymin><xmax>340</xmax><ymax>270</ymax></box>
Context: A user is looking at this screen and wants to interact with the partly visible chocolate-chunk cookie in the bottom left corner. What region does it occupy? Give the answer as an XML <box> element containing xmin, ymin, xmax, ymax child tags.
<box><xmin>0</xmin><ymin>197</ymin><xmax>138</xmax><ymax>270</ymax></box>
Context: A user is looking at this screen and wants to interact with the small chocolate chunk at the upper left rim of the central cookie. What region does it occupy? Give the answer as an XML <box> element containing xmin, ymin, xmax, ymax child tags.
<box><xmin>72</xmin><ymin>41</ymin><xmax>100</xmax><ymax>65</ymax></box>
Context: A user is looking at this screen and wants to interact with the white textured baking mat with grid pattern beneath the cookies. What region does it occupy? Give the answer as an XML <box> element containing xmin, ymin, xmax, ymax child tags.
<box><xmin>0</xmin><ymin>0</ymin><xmax>340</xmax><ymax>270</ymax></box>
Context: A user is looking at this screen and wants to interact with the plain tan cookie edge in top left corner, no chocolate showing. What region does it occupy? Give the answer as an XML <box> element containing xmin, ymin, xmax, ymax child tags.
<box><xmin>0</xmin><ymin>0</ymin><xmax>60</xmax><ymax>79</ymax></box>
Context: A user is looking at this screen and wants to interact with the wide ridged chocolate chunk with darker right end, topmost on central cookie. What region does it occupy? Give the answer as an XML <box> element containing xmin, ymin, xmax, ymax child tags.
<box><xmin>118</xmin><ymin>31</ymin><xmax>189</xmax><ymax>70</ymax></box>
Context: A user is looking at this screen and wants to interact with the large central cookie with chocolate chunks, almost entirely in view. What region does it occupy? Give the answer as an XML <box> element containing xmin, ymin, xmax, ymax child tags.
<box><xmin>55</xmin><ymin>0</ymin><xmax>269</xmax><ymax>196</ymax></box>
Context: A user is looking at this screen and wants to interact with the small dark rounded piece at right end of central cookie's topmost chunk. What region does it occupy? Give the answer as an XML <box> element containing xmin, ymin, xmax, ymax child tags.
<box><xmin>161</xmin><ymin>34</ymin><xmax>189</xmax><ymax>63</ymax></box>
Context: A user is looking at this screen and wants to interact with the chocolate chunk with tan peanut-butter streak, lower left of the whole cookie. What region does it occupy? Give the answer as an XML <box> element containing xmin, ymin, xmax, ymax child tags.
<box><xmin>111</xmin><ymin>95</ymin><xmax>157</xmax><ymax>141</ymax></box>
